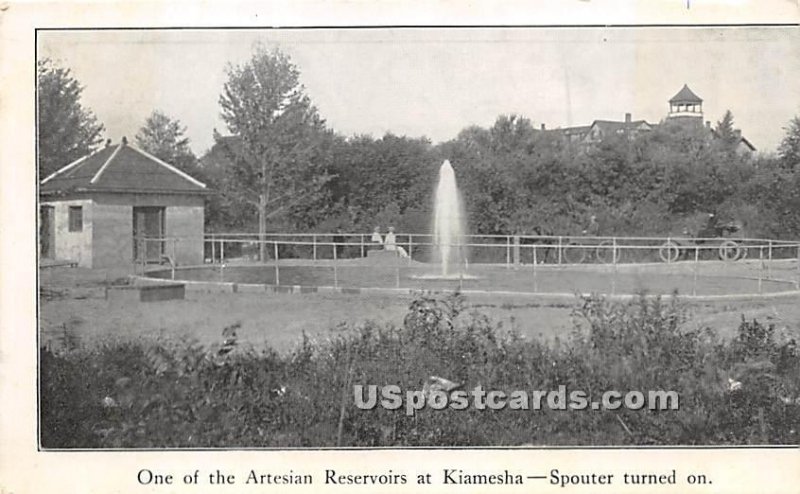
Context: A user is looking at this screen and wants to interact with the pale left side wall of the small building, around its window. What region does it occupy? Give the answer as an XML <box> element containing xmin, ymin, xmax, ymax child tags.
<box><xmin>41</xmin><ymin>199</ymin><xmax>95</xmax><ymax>268</ymax></box>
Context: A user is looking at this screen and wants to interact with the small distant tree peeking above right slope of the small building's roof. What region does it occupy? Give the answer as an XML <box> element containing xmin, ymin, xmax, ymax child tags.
<box><xmin>136</xmin><ymin>110</ymin><xmax>197</xmax><ymax>174</ymax></box>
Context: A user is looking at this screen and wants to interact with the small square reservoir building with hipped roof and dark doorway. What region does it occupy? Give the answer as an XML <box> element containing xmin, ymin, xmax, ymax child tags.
<box><xmin>39</xmin><ymin>138</ymin><xmax>208</xmax><ymax>268</ymax></box>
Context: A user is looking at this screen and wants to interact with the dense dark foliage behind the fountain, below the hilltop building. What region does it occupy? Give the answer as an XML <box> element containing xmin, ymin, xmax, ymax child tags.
<box><xmin>198</xmin><ymin>104</ymin><xmax>800</xmax><ymax>238</ymax></box>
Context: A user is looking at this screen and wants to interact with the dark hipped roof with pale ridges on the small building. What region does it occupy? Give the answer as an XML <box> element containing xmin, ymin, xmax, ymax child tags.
<box><xmin>39</xmin><ymin>140</ymin><xmax>208</xmax><ymax>194</ymax></box>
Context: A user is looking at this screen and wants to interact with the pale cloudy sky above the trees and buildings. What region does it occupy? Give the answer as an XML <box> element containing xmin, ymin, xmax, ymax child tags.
<box><xmin>37</xmin><ymin>27</ymin><xmax>800</xmax><ymax>155</ymax></box>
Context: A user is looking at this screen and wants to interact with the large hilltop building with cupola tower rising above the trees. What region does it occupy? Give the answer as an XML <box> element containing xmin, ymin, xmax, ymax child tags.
<box><xmin>542</xmin><ymin>84</ymin><xmax>756</xmax><ymax>153</ymax></box>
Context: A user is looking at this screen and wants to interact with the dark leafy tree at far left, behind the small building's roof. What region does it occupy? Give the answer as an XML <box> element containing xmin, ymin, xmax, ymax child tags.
<box><xmin>36</xmin><ymin>58</ymin><xmax>104</xmax><ymax>179</ymax></box>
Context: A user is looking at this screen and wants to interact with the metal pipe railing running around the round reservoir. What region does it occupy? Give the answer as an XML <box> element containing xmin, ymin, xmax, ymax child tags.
<box><xmin>134</xmin><ymin>233</ymin><xmax>800</xmax><ymax>296</ymax></box>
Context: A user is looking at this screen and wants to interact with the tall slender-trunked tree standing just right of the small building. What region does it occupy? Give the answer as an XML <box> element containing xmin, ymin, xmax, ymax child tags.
<box><xmin>217</xmin><ymin>46</ymin><xmax>330</xmax><ymax>259</ymax></box>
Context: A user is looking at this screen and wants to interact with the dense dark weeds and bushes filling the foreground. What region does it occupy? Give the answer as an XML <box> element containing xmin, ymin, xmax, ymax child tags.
<box><xmin>40</xmin><ymin>295</ymin><xmax>800</xmax><ymax>448</ymax></box>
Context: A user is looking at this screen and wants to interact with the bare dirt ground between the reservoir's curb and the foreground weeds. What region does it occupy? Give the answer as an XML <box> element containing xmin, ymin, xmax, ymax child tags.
<box><xmin>39</xmin><ymin>268</ymin><xmax>800</xmax><ymax>352</ymax></box>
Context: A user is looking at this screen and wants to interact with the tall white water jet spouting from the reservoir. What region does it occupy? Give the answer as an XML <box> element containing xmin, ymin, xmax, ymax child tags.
<box><xmin>433</xmin><ymin>160</ymin><xmax>465</xmax><ymax>276</ymax></box>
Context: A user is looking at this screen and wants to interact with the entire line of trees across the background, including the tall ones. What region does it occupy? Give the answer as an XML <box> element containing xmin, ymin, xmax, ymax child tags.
<box><xmin>38</xmin><ymin>47</ymin><xmax>800</xmax><ymax>238</ymax></box>
